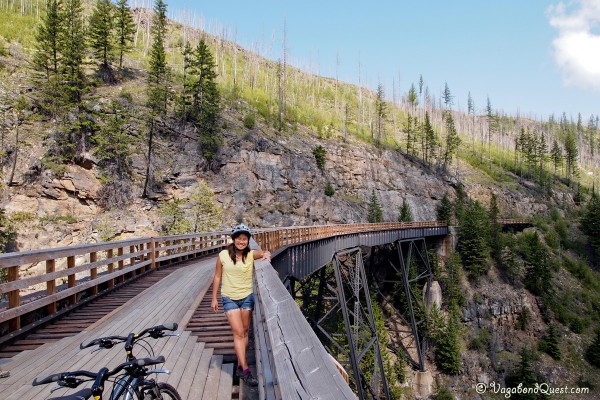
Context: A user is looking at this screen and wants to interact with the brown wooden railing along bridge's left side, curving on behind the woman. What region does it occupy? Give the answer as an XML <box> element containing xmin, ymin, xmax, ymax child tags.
<box><xmin>0</xmin><ymin>222</ymin><xmax>445</xmax><ymax>335</ymax></box>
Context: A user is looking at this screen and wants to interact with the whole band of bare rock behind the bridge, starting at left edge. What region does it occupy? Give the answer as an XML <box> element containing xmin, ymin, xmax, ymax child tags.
<box><xmin>0</xmin><ymin>119</ymin><xmax>556</xmax><ymax>250</ymax></box>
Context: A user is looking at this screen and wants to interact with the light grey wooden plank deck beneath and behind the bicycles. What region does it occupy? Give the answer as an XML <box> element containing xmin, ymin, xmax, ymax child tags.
<box><xmin>0</xmin><ymin>257</ymin><xmax>233</xmax><ymax>400</ymax></box>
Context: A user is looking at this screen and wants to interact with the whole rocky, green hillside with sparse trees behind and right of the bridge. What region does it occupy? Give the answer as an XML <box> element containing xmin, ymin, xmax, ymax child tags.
<box><xmin>0</xmin><ymin>1</ymin><xmax>600</xmax><ymax>399</ymax></box>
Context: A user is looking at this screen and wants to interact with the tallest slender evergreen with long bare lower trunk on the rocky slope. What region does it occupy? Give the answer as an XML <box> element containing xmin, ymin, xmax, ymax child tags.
<box><xmin>142</xmin><ymin>0</ymin><xmax>170</xmax><ymax>197</ymax></box>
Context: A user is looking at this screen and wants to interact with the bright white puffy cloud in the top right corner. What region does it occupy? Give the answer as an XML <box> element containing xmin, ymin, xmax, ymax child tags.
<box><xmin>547</xmin><ymin>0</ymin><xmax>600</xmax><ymax>90</ymax></box>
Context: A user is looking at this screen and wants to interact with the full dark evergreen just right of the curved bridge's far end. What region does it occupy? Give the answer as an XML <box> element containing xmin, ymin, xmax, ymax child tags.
<box><xmin>458</xmin><ymin>201</ymin><xmax>490</xmax><ymax>277</ymax></box>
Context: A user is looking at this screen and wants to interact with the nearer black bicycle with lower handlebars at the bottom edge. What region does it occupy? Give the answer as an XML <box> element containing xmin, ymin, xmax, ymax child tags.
<box><xmin>32</xmin><ymin>356</ymin><xmax>181</xmax><ymax>400</ymax></box>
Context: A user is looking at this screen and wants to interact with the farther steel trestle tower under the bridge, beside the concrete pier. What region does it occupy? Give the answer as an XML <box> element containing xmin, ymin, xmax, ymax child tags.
<box><xmin>374</xmin><ymin>238</ymin><xmax>433</xmax><ymax>371</ymax></box>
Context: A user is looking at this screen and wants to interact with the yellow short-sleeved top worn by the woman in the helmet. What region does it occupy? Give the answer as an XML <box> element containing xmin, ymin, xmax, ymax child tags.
<box><xmin>219</xmin><ymin>250</ymin><xmax>254</xmax><ymax>300</ymax></box>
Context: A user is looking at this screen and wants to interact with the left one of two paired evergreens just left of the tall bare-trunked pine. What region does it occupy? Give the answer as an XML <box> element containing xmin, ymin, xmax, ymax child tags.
<box><xmin>89</xmin><ymin>0</ymin><xmax>114</xmax><ymax>82</ymax></box>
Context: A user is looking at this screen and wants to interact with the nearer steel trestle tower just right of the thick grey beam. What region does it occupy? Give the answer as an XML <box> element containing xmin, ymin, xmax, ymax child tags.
<box><xmin>290</xmin><ymin>247</ymin><xmax>390</xmax><ymax>399</ymax></box>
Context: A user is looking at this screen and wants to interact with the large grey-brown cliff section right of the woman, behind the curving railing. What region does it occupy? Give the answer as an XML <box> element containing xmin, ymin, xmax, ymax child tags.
<box><xmin>210</xmin><ymin>132</ymin><xmax>448</xmax><ymax>226</ymax></box>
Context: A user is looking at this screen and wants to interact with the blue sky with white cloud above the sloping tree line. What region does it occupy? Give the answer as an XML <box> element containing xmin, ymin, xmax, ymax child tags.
<box><xmin>161</xmin><ymin>0</ymin><xmax>600</xmax><ymax>123</ymax></box>
